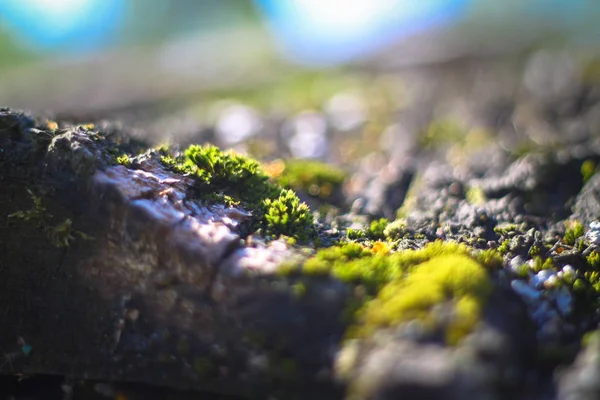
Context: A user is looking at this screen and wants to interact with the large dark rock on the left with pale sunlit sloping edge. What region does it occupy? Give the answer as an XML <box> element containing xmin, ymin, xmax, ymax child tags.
<box><xmin>0</xmin><ymin>110</ymin><xmax>347</xmax><ymax>398</ymax></box>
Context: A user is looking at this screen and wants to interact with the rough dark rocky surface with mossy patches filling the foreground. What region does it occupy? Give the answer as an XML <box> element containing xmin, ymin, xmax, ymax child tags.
<box><xmin>0</xmin><ymin>50</ymin><xmax>600</xmax><ymax>400</ymax></box>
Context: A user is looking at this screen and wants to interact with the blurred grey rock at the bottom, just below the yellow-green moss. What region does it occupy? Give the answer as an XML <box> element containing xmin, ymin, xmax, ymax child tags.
<box><xmin>336</xmin><ymin>288</ymin><xmax>536</xmax><ymax>400</ymax></box>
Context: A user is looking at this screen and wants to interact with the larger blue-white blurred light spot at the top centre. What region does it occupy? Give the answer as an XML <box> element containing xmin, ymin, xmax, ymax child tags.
<box><xmin>256</xmin><ymin>0</ymin><xmax>469</xmax><ymax>64</ymax></box>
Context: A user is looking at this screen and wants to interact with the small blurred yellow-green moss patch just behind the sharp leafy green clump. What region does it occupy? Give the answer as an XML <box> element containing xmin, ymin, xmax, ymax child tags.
<box><xmin>267</xmin><ymin>160</ymin><xmax>346</xmax><ymax>200</ymax></box>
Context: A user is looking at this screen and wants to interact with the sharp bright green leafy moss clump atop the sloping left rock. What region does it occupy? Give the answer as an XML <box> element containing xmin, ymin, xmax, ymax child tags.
<box><xmin>158</xmin><ymin>145</ymin><xmax>315</xmax><ymax>241</ymax></box>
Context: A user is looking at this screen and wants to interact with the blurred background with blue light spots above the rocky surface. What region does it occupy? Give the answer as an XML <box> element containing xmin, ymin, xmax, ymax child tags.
<box><xmin>0</xmin><ymin>0</ymin><xmax>600</xmax><ymax>171</ymax></box>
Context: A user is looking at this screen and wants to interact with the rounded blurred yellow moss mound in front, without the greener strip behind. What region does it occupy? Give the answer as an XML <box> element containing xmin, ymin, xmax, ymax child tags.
<box><xmin>355</xmin><ymin>254</ymin><xmax>491</xmax><ymax>344</ymax></box>
